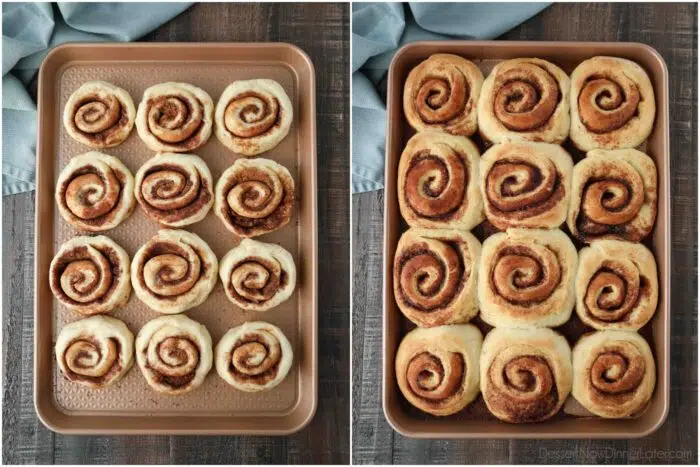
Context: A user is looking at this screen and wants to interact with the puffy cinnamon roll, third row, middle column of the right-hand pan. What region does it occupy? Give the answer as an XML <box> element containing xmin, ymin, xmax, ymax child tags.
<box><xmin>478</xmin><ymin>229</ymin><xmax>578</xmax><ymax>327</ymax></box>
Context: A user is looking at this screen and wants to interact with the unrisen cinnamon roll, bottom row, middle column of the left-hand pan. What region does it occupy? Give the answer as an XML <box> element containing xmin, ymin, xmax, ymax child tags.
<box><xmin>136</xmin><ymin>315</ymin><xmax>213</xmax><ymax>396</ymax></box>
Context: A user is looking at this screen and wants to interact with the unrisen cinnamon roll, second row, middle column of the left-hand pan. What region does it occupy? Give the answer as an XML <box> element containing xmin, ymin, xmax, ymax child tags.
<box><xmin>134</xmin><ymin>153</ymin><xmax>214</xmax><ymax>227</ymax></box>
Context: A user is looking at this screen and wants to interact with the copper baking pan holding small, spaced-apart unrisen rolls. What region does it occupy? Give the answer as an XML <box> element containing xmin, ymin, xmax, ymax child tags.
<box><xmin>34</xmin><ymin>43</ymin><xmax>318</xmax><ymax>435</ymax></box>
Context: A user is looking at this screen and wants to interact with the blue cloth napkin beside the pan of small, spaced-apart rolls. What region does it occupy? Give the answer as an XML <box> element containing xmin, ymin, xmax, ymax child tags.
<box><xmin>2</xmin><ymin>3</ymin><xmax>191</xmax><ymax>195</ymax></box>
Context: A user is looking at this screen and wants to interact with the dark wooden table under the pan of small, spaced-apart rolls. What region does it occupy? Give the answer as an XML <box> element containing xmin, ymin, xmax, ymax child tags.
<box><xmin>2</xmin><ymin>4</ymin><xmax>350</xmax><ymax>464</ymax></box>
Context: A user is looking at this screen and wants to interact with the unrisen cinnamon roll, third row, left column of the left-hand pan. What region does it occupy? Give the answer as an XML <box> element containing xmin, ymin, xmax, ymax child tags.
<box><xmin>49</xmin><ymin>235</ymin><xmax>131</xmax><ymax>315</ymax></box>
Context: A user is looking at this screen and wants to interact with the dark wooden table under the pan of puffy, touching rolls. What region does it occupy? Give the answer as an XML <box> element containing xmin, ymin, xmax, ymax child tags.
<box><xmin>352</xmin><ymin>3</ymin><xmax>698</xmax><ymax>464</ymax></box>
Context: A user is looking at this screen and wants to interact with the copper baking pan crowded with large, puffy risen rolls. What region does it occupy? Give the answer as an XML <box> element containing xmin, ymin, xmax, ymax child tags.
<box><xmin>383</xmin><ymin>41</ymin><xmax>671</xmax><ymax>439</ymax></box>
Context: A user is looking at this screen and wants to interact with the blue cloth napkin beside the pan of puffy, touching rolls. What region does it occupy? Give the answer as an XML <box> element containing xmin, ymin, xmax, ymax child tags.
<box><xmin>352</xmin><ymin>3</ymin><xmax>549</xmax><ymax>193</ymax></box>
